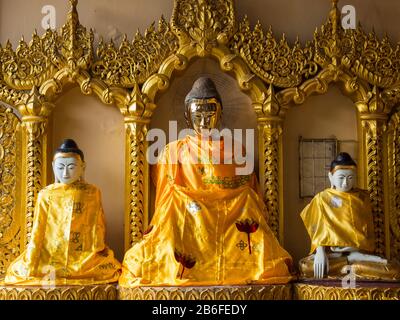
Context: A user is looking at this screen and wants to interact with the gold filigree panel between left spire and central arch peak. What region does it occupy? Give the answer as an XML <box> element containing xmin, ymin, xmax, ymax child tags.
<box><xmin>91</xmin><ymin>17</ymin><xmax>178</xmax><ymax>88</ymax></box>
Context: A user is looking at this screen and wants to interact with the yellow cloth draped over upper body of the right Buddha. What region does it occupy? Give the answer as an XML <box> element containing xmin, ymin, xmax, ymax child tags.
<box><xmin>301</xmin><ymin>188</ymin><xmax>375</xmax><ymax>253</ymax></box>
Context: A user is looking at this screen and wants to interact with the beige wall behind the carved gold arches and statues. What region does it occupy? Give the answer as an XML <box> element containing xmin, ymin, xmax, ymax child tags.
<box><xmin>0</xmin><ymin>0</ymin><xmax>400</xmax><ymax>259</ymax></box>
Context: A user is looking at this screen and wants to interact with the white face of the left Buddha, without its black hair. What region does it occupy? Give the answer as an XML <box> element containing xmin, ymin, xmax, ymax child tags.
<box><xmin>53</xmin><ymin>157</ymin><xmax>85</xmax><ymax>184</ymax></box>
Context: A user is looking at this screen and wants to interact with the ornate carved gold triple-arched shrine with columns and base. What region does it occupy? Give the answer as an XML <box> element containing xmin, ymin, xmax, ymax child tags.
<box><xmin>0</xmin><ymin>0</ymin><xmax>400</xmax><ymax>299</ymax></box>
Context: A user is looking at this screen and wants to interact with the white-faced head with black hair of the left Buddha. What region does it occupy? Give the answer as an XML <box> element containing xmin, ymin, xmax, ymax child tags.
<box><xmin>53</xmin><ymin>139</ymin><xmax>85</xmax><ymax>184</ymax></box>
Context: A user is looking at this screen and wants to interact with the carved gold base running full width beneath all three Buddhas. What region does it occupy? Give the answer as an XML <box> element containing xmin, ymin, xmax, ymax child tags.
<box><xmin>0</xmin><ymin>281</ymin><xmax>400</xmax><ymax>300</ymax></box>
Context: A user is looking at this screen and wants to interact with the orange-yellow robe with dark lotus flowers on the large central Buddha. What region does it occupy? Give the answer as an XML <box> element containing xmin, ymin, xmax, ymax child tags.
<box><xmin>119</xmin><ymin>136</ymin><xmax>292</xmax><ymax>287</ymax></box>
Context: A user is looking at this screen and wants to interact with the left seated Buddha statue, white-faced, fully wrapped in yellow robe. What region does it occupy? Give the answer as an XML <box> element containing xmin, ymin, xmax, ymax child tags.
<box><xmin>4</xmin><ymin>139</ymin><xmax>121</xmax><ymax>286</ymax></box>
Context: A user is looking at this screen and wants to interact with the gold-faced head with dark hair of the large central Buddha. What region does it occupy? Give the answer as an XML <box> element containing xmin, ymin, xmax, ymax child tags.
<box><xmin>185</xmin><ymin>77</ymin><xmax>222</xmax><ymax>135</ymax></box>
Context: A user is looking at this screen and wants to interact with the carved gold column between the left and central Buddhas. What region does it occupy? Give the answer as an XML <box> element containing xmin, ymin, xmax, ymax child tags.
<box><xmin>124</xmin><ymin>116</ymin><xmax>149</xmax><ymax>250</ymax></box>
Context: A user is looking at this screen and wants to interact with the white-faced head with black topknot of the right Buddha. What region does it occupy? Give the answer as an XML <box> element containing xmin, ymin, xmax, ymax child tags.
<box><xmin>328</xmin><ymin>152</ymin><xmax>357</xmax><ymax>192</ymax></box>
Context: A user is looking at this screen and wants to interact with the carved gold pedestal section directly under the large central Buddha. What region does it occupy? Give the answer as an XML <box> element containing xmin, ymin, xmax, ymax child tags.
<box><xmin>119</xmin><ymin>284</ymin><xmax>292</xmax><ymax>300</ymax></box>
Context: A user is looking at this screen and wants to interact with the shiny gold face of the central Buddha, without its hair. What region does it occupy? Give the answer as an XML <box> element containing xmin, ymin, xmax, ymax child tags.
<box><xmin>189</xmin><ymin>102</ymin><xmax>221</xmax><ymax>134</ymax></box>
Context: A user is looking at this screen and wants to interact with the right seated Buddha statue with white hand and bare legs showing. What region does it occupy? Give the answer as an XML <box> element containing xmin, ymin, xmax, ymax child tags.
<box><xmin>299</xmin><ymin>152</ymin><xmax>400</xmax><ymax>281</ymax></box>
